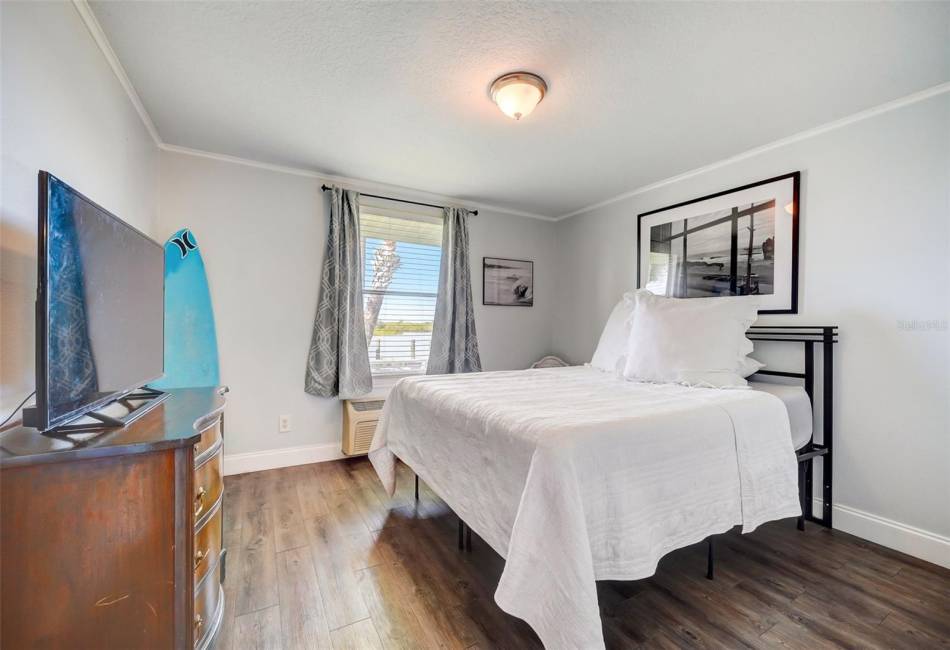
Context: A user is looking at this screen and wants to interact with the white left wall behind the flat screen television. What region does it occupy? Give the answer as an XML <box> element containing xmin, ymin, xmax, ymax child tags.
<box><xmin>0</xmin><ymin>2</ymin><xmax>158</xmax><ymax>416</ymax></box>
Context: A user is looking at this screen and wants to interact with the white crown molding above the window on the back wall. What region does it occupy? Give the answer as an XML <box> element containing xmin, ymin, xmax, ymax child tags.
<box><xmin>158</xmin><ymin>142</ymin><xmax>555</xmax><ymax>222</ymax></box>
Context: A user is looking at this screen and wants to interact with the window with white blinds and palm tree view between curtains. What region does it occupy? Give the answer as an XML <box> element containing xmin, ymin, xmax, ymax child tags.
<box><xmin>360</xmin><ymin>205</ymin><xmax>442</xmax><ymax>377</ymax></box>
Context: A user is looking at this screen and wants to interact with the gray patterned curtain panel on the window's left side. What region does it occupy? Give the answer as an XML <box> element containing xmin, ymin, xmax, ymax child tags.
<box><xmin>304</xmin><ymin>187</ymin><xmax>373</xmax><ymax>399</ymax></box>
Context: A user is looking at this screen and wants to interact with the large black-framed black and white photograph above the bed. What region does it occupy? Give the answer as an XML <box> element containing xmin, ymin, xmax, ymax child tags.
<box><xmin>637</xmin><ymin>172</ymin><xmax>801</xmax><ymax>314</ymax></box>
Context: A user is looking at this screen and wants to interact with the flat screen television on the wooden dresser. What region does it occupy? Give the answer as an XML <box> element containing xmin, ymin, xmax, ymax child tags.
<box><xmin>24</xmin><ymin>172</ymin><xmax>165</xmax><ymax>431</ymax></box>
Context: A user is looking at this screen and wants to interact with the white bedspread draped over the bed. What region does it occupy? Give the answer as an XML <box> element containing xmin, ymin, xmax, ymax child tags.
<box><xmin>370</xmin><ymin>367</ymin><xmax>801</xmax><ymax>649</ymax></box>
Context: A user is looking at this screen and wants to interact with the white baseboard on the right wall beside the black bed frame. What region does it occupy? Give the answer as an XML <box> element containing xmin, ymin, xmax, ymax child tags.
<box><xmin>812</xmin><ymin>499</ymin><xmax>950</xmax><ymax>569</ymax></box>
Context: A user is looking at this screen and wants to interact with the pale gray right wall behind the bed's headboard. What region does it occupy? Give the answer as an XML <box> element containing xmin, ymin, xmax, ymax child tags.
<box><xmin>554</xmin><ymin>93</ymin><xmax>950</xmax><ymax>563</ymax></box>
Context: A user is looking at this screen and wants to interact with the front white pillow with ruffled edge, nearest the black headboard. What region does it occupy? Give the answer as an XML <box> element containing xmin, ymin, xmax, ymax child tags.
<box><xmin>623</xmin><ymin>291</ymin><xmax>758</xmax><ymax>388</ymax></box>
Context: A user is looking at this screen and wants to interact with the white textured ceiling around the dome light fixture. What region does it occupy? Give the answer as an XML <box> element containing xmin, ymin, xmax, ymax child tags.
<box><xmin>92</xmin><ymin>2</ymin><xmax>950</xmax><ymax>216</ymax></box>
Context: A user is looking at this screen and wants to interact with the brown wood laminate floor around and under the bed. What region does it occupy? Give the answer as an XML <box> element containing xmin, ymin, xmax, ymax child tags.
<box><xmin>218</xmin><ymin>459</ymin><xmax>950</xmax><ymax>650</ymax></box>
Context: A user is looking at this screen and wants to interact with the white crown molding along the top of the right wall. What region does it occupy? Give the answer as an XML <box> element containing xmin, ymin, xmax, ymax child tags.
<box><xmin>554</xmin><ymin>82</ymin><xmax>950</xmax><ymax>221</ymax></box>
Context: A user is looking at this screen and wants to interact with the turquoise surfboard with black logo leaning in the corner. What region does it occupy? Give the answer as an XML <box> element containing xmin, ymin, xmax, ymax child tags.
<box><xmin>150</xmin><ymin>228</ymin><xmax>218</xmax><ymax>389</ymax></box>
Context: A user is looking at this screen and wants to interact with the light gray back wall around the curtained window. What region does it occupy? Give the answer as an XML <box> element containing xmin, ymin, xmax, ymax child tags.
<box><xmin>158</xmin><ymin>152</ymin><xmax>555</xmax><ymax>460</ymax></box>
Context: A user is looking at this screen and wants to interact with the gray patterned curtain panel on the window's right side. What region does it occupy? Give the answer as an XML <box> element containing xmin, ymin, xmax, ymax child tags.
<box><xmin>426</xmin><ymin>208</ymin><xmax>482</xmax><ymax>375</ymax></box>
